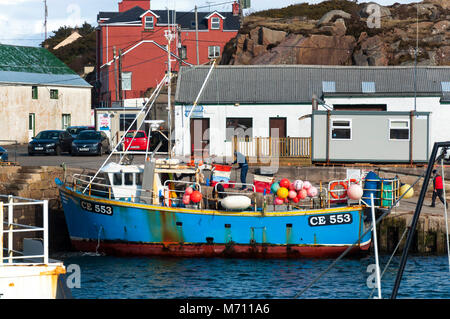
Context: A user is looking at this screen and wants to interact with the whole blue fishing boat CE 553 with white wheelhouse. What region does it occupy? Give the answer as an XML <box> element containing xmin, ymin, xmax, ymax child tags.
<box><xmin>57</xmin><ymin>160</ymin><xmax>380</xmax><ymax>258</ymax></box>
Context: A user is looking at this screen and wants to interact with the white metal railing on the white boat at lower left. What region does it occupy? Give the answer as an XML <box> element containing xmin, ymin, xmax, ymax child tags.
<box><xmin>0</xmin><ymin>195</ymin><xmax>49</xmax><ymax>266</ymax></box>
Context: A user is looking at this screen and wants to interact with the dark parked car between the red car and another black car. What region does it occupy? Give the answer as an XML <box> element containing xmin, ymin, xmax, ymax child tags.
<box><xmin>72</xmin><ymin>130</ymin><xmax>111</xmax><ymax>156</ymax></box>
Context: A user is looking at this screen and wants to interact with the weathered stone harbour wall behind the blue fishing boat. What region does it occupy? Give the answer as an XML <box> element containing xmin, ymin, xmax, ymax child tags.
<box><xmin>0</xmin><ymin>166</ymin><xmax>450</xmax><ymax>254</ymax></box>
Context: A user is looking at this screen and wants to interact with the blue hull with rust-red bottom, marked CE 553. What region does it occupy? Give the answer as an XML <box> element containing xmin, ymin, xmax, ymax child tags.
<box><xmin>59</xmin><ymin>186</ymin><xmax>371</xmax><ymax>258</ymax></box>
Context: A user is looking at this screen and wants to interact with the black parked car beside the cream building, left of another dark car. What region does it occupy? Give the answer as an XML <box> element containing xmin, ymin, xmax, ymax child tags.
<box><xmin>28</xmin><ymin>130</ymin><xmax>73</xmax><ymax>155</ymax></box>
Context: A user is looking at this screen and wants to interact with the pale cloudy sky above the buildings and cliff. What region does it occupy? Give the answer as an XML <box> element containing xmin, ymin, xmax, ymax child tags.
<box><xmin>0</xmin><ymin>0</ymin><xmax>417</xmax><ymax>46</ymax></box>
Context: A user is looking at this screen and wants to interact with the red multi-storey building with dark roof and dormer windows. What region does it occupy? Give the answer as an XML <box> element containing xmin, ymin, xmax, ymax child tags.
<box><xmin>97</xmin><ymin>0</ymin><xmax>239</xmax><ymax>107</ymax></box>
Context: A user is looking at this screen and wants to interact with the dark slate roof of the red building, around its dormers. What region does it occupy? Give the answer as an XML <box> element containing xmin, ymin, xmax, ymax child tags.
<box><xmin>97</xmin><ymin>7</ymin><xmax>239</xmax><ymax>30</ymax></box>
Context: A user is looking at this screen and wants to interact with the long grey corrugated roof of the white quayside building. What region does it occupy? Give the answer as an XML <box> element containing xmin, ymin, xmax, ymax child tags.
<box><xmin>175</xmin><ymin>65</ymin><xmax>450</xmax><ymax>104</ymax></box>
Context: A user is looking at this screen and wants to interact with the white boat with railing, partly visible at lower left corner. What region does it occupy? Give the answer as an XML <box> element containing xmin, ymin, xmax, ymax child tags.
<box><xmin>0</xmin><ymin>195</ymin><xmax>71</xmax><ymax>299</ymax></box>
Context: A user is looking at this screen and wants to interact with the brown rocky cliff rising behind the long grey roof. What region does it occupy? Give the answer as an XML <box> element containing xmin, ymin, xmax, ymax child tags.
<box><xmin>220</xmin><ymin>0</ymin><xmax>450</xmax><ymax>66</ymax></box>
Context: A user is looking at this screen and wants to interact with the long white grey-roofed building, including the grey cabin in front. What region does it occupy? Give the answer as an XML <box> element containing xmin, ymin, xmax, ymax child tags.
<box><xmin>174</xmin><ymin>65</ymin><xmax>450</xmax><ymax>162</ymax></box>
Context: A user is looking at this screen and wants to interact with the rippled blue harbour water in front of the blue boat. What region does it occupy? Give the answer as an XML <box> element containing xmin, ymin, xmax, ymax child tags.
<box><xmin>60</xmin><ymin>255</ymin><xmax>450</xmax><ymax>299</ymax></box>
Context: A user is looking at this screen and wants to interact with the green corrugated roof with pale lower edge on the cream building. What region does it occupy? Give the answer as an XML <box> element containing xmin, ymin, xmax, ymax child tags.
<box><xmin>0</xmin><ymin>44</ymin><xmax>91</xmax><ymax>87</ymax></box>
